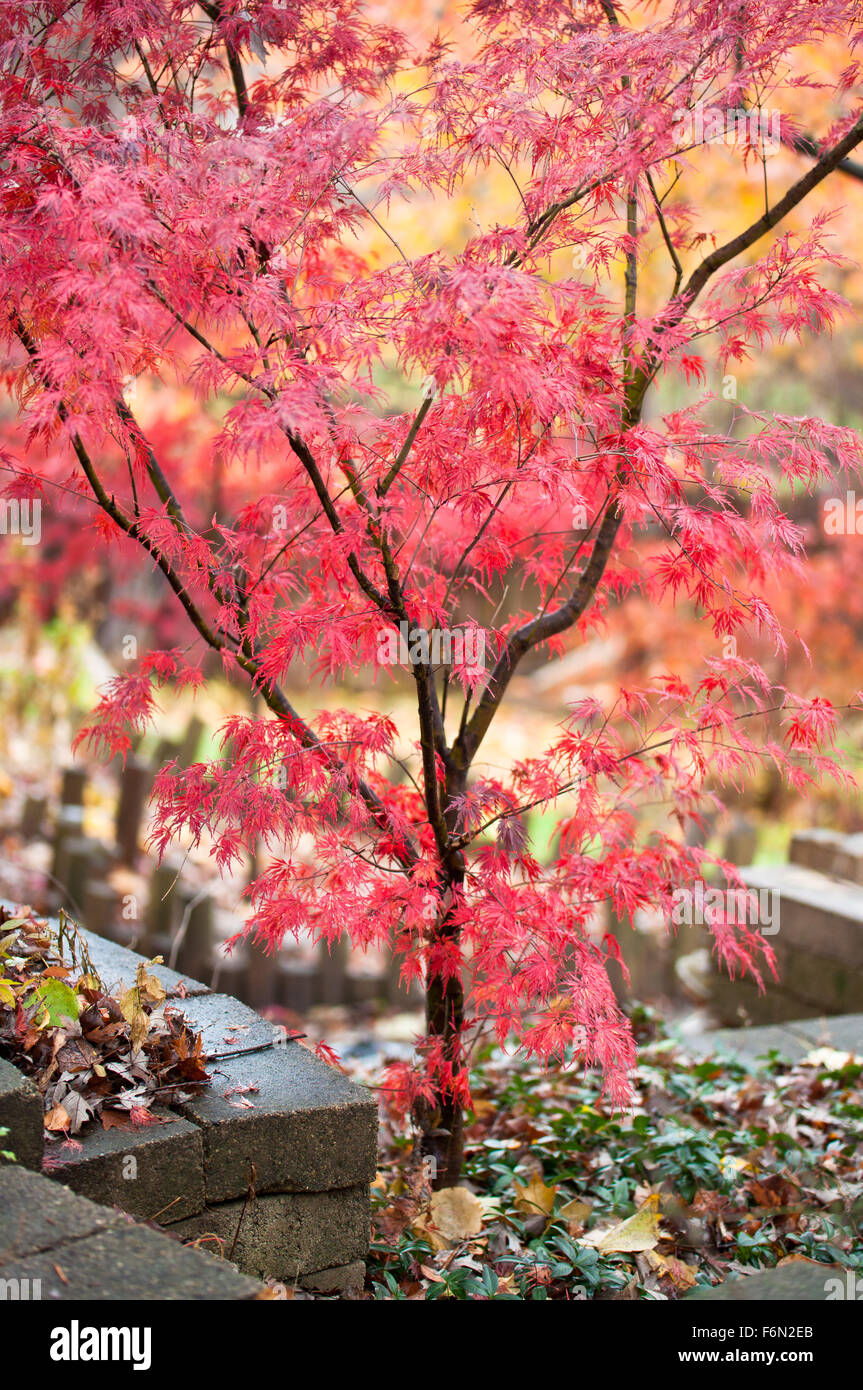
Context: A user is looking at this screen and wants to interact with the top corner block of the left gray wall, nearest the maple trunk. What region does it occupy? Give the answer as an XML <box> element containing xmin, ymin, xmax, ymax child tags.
<box><xmin>178</xmin><ymin>1043</ymin><xmax>378</xmax><ymax>1200</ymax></box>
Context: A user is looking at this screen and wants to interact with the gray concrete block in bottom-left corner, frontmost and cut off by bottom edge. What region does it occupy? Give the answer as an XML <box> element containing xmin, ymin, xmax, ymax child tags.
<box><xmin>1</xmin><ymin>1225</ymin><xmax>261</xmax><ymax>1302</ymax></box>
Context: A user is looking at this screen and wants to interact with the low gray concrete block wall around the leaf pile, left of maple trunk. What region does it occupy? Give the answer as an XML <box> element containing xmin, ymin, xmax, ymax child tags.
<box><xmin>0</xmin><ymin>933</ymin><xmax>377</xmax><ymax>1293</ymax></box>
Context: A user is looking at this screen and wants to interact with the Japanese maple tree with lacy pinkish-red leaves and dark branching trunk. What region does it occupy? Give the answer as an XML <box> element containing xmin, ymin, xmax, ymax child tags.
<box><xmin>0</xmin><ymin>0</ymin><xmax>863</xmax><ymax>1184</ymax></box>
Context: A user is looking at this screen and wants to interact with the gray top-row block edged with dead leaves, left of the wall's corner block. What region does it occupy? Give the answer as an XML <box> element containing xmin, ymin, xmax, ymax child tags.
<box><xmin>49</xmin><ymin>1112</ymin><xmax>204</xmax><ymax>1226</ymax></box>
